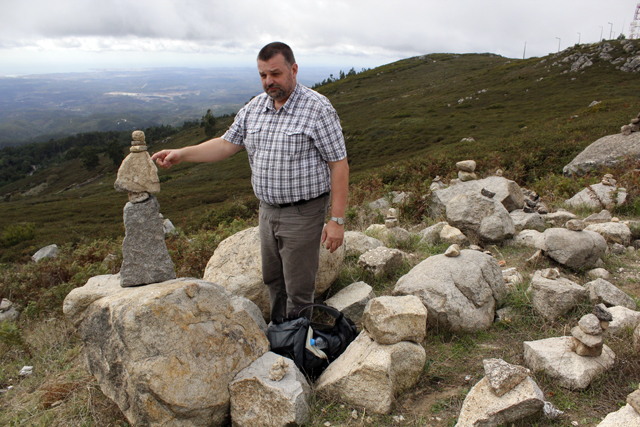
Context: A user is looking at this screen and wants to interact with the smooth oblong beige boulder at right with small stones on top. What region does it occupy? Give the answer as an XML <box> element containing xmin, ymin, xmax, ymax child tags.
<box><xmin>542</xmin><ymin>228</ymin><xmax>607</xmax><ymax>269</ymax></box>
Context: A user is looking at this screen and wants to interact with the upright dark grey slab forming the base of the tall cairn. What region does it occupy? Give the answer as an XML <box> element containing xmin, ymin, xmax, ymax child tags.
<box><xmin>120</xmin><ymin>196</ymin><xmax>176</xmax><ymax>287</ymax></box>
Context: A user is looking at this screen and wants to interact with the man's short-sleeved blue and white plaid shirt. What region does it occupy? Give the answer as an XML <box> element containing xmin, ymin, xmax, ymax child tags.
<box><xmin>223</xmin><ymin>84</ymin><xmax>347</xmax><ymax>204</ymax></box>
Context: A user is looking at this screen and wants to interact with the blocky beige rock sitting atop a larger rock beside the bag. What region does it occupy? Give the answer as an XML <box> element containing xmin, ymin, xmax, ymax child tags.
<box><xmin>362</xmin><ymin>295</ymin><xmax>427</xmax><ymax>344</ymax></box>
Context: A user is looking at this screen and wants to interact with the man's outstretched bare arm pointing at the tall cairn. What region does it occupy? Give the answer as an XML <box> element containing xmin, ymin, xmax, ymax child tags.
<box><xmin>151</xmin><ymin>138</ymin><xmax>243</xmax><ymax>169</ymax></box>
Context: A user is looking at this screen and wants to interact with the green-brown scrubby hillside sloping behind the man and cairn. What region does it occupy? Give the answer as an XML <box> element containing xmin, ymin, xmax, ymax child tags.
<box><xmin>0</xmin><ymin>41</ymin><xmax>640</xmax><ymax>261</ymax></box>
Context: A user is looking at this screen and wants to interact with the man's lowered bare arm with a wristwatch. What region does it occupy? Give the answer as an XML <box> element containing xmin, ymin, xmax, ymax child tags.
<box><xmin>322</xmin><ymin>157</ymin><xmax>349</xmax><ymax>253</ymax></box>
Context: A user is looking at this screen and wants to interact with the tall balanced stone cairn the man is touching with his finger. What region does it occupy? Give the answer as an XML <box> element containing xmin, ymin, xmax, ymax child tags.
<box><xmin>113</xmin><ymin>130</ymin><xmax>176</xmax><ymax>287</ymax></box>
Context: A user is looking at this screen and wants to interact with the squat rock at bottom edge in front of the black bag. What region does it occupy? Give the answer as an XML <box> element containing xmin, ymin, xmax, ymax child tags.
<box><xmin>229</xmin><ymin>351</ymin><xmax>311</xmax><ymax>427</ymax></box>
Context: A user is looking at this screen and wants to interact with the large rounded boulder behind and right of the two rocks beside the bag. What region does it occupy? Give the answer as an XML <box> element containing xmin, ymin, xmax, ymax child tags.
<box><xmin>393</xmin><ymin>249</ymin><xmax>507</xmax><ymax>331</ymax></box>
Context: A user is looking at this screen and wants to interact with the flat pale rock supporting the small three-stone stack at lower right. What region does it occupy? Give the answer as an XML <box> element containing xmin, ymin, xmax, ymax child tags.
<box><xmin>524</xmin><ymin>336</ymin><xmax>616</xmax><ymax>390</ymax></box>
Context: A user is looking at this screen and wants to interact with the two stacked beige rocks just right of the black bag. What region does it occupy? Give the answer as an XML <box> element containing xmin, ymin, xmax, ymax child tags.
<box><xmin>316</xmin><ymin>296</ymin><xmax>427</xmax><ymax>414</ymax></box>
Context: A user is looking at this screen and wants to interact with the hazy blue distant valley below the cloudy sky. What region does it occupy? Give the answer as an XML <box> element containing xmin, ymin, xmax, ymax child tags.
<box><xmin>0</xmin><ymin>67</ymin><xmax>335</xmax><ymax>146</ymax></box>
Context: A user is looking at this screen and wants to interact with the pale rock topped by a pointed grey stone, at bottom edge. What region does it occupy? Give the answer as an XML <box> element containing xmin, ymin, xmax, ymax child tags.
<box><xmin>456</xmin><ymin>359</ymin><xmax>545</xmax><ymax>427</ymax></box>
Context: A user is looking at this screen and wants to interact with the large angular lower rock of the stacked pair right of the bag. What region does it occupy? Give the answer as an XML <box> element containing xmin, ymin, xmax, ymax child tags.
<box><xmin>315</xmin><ymin>331</ymin><xmax>426</xmax><ymax>414</ymax></box>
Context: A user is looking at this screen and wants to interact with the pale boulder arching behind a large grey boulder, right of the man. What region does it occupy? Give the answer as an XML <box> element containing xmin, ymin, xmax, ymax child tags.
<box><xmin>430</xmin><ymin>176</ymin><xmax>524</xmax><ymax>217</ymax></box>
